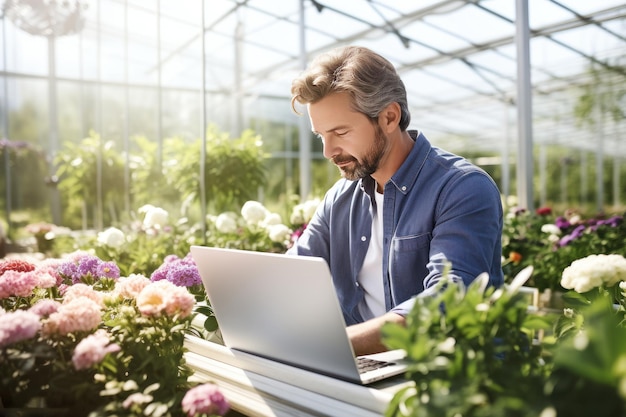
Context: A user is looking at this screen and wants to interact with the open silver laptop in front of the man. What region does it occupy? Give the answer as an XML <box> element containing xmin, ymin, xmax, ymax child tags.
<box><xmin>191</xmin><ymin>246</ymin><xmax>407</xmax><ymax>384</ymax></box>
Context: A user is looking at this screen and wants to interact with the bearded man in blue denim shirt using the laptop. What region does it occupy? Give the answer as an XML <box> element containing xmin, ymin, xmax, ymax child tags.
<box><xmin>290</xmin><ymin>47</ymin><xmax>503</xmax><ymax>355</ymax></box>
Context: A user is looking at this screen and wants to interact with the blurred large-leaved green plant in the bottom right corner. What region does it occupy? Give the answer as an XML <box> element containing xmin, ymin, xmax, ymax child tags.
<box><xmin>546</xmin><ymin>291</ymin><xmax>626</xmax><ymax>417</ymax></box>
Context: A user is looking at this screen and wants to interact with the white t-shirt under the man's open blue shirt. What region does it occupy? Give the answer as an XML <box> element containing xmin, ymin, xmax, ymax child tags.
<box><xmin>357</xmin><ymin>192</ymin><xmax>387</xmax><ymax>320</ymax></box>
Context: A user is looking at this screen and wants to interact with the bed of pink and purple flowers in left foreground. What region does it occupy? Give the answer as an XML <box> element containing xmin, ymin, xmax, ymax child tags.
<box><xmin>0</xmin><ymin>252</ymin><xmax>228</xmax><ymax>417</ymax></box>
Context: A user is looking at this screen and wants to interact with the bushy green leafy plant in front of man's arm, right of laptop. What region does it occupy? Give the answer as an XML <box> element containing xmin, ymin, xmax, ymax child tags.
<box><xmin>383</xmin><ymin>270</ymin><xmax>550</xmax><ymax>417</ymax></box>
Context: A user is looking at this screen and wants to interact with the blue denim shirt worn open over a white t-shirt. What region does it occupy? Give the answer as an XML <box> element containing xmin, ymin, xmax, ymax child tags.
<box><xmin>289</xmin><ymin>131</ymin><xmax>503</xmax><ymax>325</ymax></box>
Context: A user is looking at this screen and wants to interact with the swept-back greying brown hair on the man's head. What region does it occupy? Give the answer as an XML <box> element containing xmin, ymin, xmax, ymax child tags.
<box><xmin>291</xmin><ymin>46</ymin><xmax>411</xmax><ymax>131</ymax></box>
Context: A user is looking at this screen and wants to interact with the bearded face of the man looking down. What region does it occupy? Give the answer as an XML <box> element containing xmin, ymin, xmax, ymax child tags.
<box><xmin>309</xmin><ymin>93</ymin><xmax>388</xmax><ymax>180</ymax></box>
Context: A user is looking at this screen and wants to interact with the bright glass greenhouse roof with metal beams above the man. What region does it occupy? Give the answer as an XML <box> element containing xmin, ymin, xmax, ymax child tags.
<box><xmin>4</xmin><ymin>0</ymin><xmax>626</xmax><ymax>156</ymax></box>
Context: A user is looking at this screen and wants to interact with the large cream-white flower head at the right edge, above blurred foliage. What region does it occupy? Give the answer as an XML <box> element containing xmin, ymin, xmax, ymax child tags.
<box><xmin>561</xmin><ymin>254</ymin><xmax>626</xmax><ymax>293</ymax></box>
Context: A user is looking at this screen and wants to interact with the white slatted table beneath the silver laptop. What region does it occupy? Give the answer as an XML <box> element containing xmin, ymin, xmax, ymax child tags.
<box><xmin>185</xmin><ymin>336</ymin><xmax>410</xmax><ymax>417</ymax></box>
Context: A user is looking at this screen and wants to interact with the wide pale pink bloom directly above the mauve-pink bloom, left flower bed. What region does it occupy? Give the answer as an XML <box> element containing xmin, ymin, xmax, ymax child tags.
<box><xmin>42</xmin><ymin>297</ymin><xmax>102</xmax><ymax>335</ymax></box>
